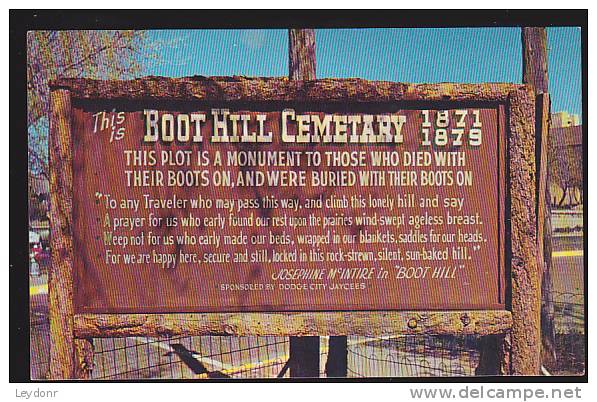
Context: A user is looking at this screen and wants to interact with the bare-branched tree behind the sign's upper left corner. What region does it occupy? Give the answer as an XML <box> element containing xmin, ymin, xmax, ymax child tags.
<box><xmin>27</xmin><ymin>31</ymin><xmax>150</xmax><ymax>178</ymax></box>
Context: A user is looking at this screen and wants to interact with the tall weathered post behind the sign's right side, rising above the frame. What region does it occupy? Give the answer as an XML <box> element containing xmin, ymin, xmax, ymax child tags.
<box><xmin>522</xmin><ymin>27</ymin><xmax>557</xmax><ymax>365</ymax></box>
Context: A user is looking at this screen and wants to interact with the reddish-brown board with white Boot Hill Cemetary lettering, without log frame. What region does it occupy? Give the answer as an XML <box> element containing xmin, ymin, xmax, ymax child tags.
<box><xmin>72</xmin><ymin>100</ymin><xmax>505</xmax><ymax>313</ymax></box>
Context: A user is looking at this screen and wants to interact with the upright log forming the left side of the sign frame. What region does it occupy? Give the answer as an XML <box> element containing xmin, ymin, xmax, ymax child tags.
<box><xmin>48</xmin><ymin>89</ymin><xmax>75</xmax><ymax>379</ymax></box>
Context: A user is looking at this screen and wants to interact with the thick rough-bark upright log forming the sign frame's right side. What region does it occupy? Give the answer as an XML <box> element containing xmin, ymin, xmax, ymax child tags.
<box><xmin>509</xmin><ymin>85</ymin><xmax>541</xmax><ymax>375</ymax></box>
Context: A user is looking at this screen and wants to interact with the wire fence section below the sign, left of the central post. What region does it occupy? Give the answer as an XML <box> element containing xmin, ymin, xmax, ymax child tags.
<box><xmin>92</xmin><ymin>336</ymin><xmax>288</xmax><ymax>380</ymax></box>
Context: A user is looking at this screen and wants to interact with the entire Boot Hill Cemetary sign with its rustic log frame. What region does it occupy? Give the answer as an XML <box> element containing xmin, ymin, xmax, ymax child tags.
<box><xmin>49</xmin><ymin>77</ymin><xmax>540</xmax><ymax>377</ymax></box>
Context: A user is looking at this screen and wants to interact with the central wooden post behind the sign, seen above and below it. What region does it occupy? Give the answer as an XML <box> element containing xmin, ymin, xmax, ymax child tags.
<box><xmin>288</xmin><ymin>29</ymin><xmax>319</xmax><ymax>378</ymax></box>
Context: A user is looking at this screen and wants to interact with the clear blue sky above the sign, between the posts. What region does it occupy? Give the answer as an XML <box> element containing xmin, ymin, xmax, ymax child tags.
<box><xmin>143</xmin><ymin>27</ymin><xmax>582</xmax><ymax>115</ymax></box>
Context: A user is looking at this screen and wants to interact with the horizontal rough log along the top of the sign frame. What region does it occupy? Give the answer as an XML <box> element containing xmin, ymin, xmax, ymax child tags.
<box><xmin>50</xmin><ymin>76</ymin><xmax>523</xmax><ymax>102</ymax></box>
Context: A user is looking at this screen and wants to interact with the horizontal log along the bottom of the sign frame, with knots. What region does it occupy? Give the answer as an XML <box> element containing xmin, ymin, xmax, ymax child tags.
<box><xmin>74</xmin><ymin>310</ymin><xmax>512</xmax><ymax>338</ymax></box>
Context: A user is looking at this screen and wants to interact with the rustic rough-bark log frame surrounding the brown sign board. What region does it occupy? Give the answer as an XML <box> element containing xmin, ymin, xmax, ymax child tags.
<box><xmin>49</xmin><ymin>77</ymin><xmax>541</xmax><ymax>379</ymax></box>
